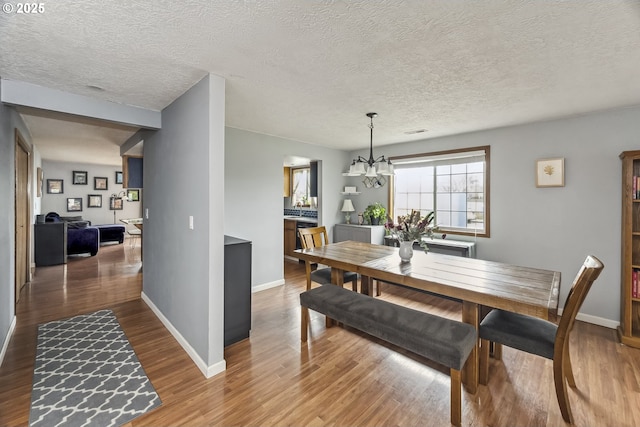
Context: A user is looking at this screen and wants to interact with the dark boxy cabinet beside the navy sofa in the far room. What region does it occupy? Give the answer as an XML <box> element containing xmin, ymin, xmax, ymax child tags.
<box><xmin>34</xmin><ymin>221</ymin><xmax>67</xmax><ymax>267</ymax></box>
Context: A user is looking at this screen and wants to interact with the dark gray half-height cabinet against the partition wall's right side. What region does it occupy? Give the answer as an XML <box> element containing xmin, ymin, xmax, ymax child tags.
<box><xmin>224</xmin><ymin>236</ymin><xmax>251</xmax><ymax>347</ymax></box>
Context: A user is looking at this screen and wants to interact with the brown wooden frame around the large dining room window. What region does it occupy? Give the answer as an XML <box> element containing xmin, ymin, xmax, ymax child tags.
<box><xmin>388</xmin><ymin>145</ymin><xmax>491</xmax><ymax>237</ymax></box>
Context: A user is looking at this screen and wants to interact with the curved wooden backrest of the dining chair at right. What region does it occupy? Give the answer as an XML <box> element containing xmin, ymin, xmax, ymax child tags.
<box><xmin>554</xmin><ymin>255</ymin><xmax>604</xmax><ymax>352</ymax></box>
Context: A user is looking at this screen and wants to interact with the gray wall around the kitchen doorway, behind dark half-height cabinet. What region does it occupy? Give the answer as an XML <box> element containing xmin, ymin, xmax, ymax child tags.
<box><xmin>224</xmin><ymin>128</ymin><xmax>348</xmax><ymax>289</ymax></box>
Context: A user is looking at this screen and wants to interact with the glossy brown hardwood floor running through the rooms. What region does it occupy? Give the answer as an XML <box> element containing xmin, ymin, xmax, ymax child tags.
<box><xmin>0</xmin><ymin>243</ymin><xmax>640</xmax><ymax>426</ymax></box>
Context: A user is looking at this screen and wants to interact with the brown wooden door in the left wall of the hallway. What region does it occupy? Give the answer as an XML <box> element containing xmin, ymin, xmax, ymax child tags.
<box><xmin>15</xmin><ymin>130</ymin><xmax>30</xmax><ymax>304</ymax></box>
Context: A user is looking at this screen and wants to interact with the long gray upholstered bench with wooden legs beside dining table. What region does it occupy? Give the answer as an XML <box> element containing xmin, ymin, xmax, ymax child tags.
<box><xmin>300</xmin><ymin>285</ymin><xmax>477</xmax><ymax>426</ymax></box>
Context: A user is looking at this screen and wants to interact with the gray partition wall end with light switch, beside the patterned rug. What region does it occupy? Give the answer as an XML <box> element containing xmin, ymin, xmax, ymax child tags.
<box><xmin>143</xmin><ymin>75</ymin><xmax>225</xmax><ymax>366</ymax></box>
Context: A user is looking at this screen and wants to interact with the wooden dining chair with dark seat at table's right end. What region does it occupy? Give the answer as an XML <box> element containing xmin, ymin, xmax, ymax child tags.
<box><xmin>479</xmin><ymin>255</ymin><xmax>604</xmax><ymax>424</ymax></box>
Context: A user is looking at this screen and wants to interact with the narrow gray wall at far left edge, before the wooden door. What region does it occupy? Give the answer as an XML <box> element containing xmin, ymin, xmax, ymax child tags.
<box><xmin>0</xmin><ymin>98</ymin><xmax>31</xmax><ymax>356</ymax></box>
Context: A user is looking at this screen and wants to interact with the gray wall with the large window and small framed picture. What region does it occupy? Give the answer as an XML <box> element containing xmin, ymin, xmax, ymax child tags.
<box><xmin>349</xmin><ymin>108</ymin><xmax>640</xmax><ymax>327</ymax></box>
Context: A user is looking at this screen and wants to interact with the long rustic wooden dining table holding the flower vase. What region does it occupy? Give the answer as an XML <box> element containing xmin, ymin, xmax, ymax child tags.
<box><xmin>295</xmin><ymin>241</ymin><xmax>560</xmax><ymax>394</ymax></box>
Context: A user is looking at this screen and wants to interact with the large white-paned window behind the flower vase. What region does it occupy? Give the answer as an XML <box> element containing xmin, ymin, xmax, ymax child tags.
<box><xmin>389</xmin><ymin>146</ymin><xmax>489</xmax><ymax>237</ymax></box>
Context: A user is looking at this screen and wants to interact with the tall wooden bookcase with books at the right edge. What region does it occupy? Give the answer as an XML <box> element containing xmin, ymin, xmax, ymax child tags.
<box><xmin>618</xmin><ymin>151</ymin><xmax>640</xmax><ymax>348</ymax></box>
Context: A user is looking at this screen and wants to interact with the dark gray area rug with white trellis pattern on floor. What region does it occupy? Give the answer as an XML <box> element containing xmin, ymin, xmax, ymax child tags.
<box><xmin>29</xmin><ymin>310</ymin><xmax>162</xmax><ymax>427</ymax></box>
